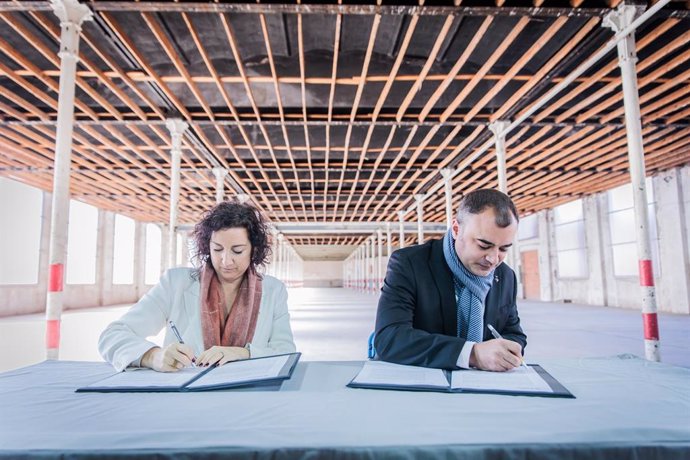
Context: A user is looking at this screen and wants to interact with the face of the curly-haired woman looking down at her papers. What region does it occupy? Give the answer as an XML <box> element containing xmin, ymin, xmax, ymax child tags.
<box><xmin>209</xmin><ymin>227</ymin><xmax>252</xmax><ymax>283</ymax></box>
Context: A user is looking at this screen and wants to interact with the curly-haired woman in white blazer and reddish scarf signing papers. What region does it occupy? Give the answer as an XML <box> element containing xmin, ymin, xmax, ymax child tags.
<box><xmin>98</xmin><ymin>202</ymin><xmax>295</xmax><ymax>372</ymax></box>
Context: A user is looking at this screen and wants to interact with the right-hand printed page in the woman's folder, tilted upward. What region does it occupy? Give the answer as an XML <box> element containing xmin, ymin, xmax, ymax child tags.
<box><xmin>188</xmin><ymin>355</ymin><xmax>290</xmax><ymax>388</ymax></box>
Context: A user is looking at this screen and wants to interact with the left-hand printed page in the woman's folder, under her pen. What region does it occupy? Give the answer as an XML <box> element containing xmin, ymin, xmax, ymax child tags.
<box><xmin>86</xmin><ymin>367</ymin><xmax>205</xmax><ymax>389</ymax></box>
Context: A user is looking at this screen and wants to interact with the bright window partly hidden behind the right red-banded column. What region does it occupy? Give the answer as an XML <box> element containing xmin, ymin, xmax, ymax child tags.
<box><xmin>607</xmin><ymin>177</ymin><xmax>660</xmax><ymax>276</ymax></box>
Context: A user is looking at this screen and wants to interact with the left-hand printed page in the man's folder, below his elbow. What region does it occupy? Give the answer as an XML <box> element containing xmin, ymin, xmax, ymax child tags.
<box><xmin>352</xmin><ymin>361</ymin><xmax>448</xmax><ymax>388</ymax></box>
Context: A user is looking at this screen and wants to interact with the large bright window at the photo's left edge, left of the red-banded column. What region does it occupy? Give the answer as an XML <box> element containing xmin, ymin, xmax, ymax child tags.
<box><xmin>0</xmin><ymin>177</ymin><xmax>43</xmax><ymax>284</ymax></box>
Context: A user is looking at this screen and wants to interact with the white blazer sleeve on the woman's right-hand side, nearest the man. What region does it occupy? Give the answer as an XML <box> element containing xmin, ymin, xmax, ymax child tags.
<box><xmin>249</xmin><ymin>283</ymin><xmax>296</xmax><ymax>358</ymax></box>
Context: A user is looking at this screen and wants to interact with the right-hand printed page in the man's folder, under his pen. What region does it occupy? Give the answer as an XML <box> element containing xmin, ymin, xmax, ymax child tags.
<box><xmin>450</xmin><ymin>366</ymin><xmax>553</xmax><ymax>393</ymax></box>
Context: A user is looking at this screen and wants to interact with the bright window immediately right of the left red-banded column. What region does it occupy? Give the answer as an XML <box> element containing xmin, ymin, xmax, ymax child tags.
<box><xmin>65</xmin><ymin>200</ymin><xmax>98</xmax><ymax>284</ymax></box>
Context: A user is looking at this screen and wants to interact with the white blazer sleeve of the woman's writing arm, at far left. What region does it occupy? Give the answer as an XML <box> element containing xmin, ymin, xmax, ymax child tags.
<box><xmin>98</xmin><ymin>271</ymin><xmax>173</xmax><ymax>372</ymax></box>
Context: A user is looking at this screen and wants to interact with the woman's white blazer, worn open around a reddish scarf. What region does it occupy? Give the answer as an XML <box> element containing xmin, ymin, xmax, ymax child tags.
<box><xmin>98</xmin><ymin>268</ymin><xmax>295</xmax><ymax>371</ymax></box>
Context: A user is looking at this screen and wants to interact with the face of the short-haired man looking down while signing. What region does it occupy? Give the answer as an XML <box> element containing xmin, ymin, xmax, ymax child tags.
<box><xmin>451</xmin><ymin>208</ymin><xmax>517</xmax><ymax>276</ymax></box>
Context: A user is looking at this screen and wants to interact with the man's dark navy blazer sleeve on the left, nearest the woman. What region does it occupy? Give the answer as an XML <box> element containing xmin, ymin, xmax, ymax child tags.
<box><xmin>374</xmin><ymin>251</ymin><xmax>465</xmax><ymax>369</ymax></box>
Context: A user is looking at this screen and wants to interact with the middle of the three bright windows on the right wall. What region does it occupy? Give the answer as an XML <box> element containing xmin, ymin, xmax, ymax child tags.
<box><xmin>554</xmin><ymin>200</ymin><xmax>588</xmax><ymax>278</ymax></box>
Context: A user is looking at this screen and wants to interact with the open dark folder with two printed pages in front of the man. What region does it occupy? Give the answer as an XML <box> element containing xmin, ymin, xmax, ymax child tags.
<box><xmin>348</xmin><ymin>361</ymin><xmax>575</xmax><ymax>398</ymax></box>
